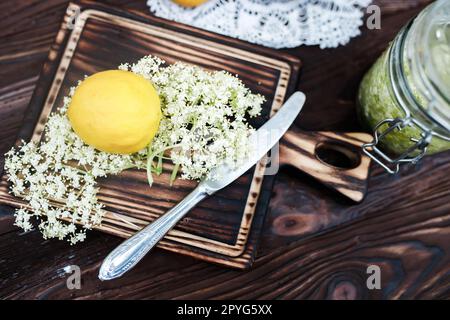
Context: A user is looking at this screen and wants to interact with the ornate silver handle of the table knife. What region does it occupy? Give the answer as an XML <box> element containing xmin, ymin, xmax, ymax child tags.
<box><xmin>98</xmin><ymin>184</ymin><xmax>207</xmax><ymax>280</ymax></box>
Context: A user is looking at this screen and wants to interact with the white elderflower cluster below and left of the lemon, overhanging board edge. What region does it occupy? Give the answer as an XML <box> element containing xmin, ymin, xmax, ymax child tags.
<box><xmin>5</xmin><ymin>97</ymin><xmax>132</xmax><ymax>244</ymax></box>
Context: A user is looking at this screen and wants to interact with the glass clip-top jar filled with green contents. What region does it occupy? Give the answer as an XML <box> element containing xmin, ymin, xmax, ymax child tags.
<box><xmin>358</xmin><ymin>0</ymin><xmax>450</xmax><ymax>174</ymax></box>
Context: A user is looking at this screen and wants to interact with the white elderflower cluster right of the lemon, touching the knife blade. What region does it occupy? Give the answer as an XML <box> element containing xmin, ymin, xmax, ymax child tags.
<box><xmin>119</xmin><ymin>56</ymin><xmax>264</xmax><ymax>180</ymax></box>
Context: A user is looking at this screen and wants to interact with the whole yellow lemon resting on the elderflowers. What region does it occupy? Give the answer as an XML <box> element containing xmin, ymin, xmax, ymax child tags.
<box><xmin>67</xmin><ymin>70</ymin><xmax>161</xmax><ymax>154</ymax></box>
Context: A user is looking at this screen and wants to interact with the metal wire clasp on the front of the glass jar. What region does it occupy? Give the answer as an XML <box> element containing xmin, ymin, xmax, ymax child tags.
<box><xmin>362</xmin><ymin>117</ymin><xmax>433</xmax><ymax>174</ymax></box>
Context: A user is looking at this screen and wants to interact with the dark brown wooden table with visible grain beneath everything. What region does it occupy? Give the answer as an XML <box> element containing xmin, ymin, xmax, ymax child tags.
<box><xmin>0</xmin><ymin>0</ymin><xmax>450</xmax><ymax>299</ymax></box>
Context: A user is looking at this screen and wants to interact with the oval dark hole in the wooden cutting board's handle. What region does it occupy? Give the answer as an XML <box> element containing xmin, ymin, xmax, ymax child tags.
<box><xmin>314</xmin><ymin>141</ymin><xmax>361</xmax><ymax>170</ymax></box>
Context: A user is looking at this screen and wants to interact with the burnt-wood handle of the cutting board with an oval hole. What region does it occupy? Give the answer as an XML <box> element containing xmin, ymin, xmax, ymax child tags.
<box><xmin>279</xmin><ymin>127</ymin><xmax>372</xmax><ymax>202</ymax></box>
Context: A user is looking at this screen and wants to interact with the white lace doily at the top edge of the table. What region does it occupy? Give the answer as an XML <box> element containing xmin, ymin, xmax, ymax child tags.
<box><xmin>147</xmin><ymin>0</ymin><xmax>371</xmax><ymax>48</ymax></box>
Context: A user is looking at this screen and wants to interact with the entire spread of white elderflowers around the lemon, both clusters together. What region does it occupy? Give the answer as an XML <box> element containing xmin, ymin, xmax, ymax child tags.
<box><xmin>5</xmin><ymin>56</ymin><xmax>264</xmax><ymax>244</ymax></box>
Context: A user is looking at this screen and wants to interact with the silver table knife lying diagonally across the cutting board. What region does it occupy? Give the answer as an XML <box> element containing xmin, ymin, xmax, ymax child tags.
<box><xmin>98</xmin><ymin>92</ymin><xmax>306</xmax><ymax>281</ymax></box>
